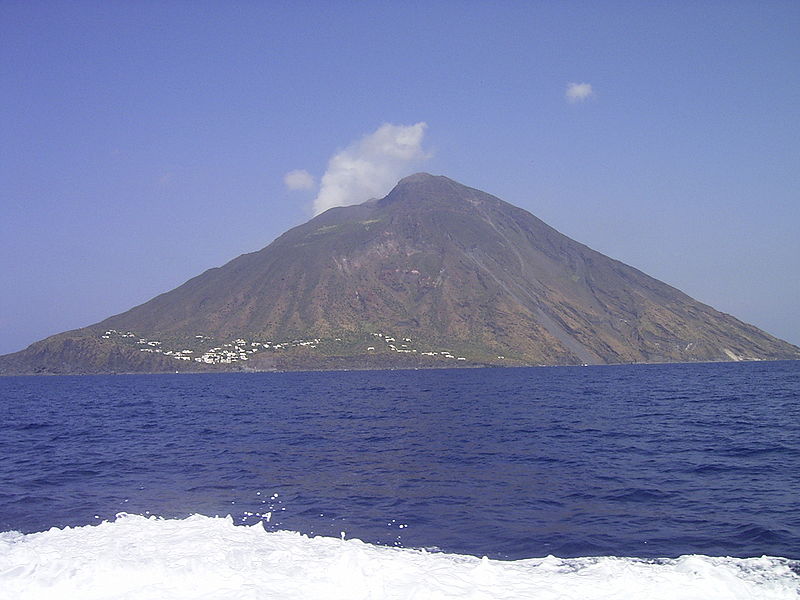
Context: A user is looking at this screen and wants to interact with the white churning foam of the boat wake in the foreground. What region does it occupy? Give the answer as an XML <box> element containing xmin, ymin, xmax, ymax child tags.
<box><xmin>0</xmin><ymin>514</ymin><xmax>800</xmax><ymax>600</ymax></box>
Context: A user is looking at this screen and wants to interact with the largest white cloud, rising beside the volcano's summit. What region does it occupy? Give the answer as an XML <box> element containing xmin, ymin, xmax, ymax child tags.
<box><xmin>314</xmin><ymin>122</ymin><xmax>429</xmax><ymax>215</ymax></box>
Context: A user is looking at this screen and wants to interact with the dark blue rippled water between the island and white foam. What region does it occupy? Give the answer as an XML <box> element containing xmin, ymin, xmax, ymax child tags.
<box><xmin>0</xmin><ymin>362</ymin><xmax>800</xmax><ymax>558</ymax></box>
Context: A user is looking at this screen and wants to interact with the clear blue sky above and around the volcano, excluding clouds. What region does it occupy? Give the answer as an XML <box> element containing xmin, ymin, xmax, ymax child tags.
<box><xmin>0</xmin><ymin>0</ymin><xmax>800</xmax><ymax>353</ymax></box>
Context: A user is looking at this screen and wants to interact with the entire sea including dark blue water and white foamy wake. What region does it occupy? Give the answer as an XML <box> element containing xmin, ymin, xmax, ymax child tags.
<box><xmin>0</xmin><ymin>361</ymin><xmax>800</xmax><ymax>600</ymax></box>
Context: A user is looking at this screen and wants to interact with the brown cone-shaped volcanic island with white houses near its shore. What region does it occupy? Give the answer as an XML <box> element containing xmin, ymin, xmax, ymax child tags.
<box><xmin>0</xmin><ymin>174</ymin><xmax>800</xmax><ymax>372</ymax></box>
